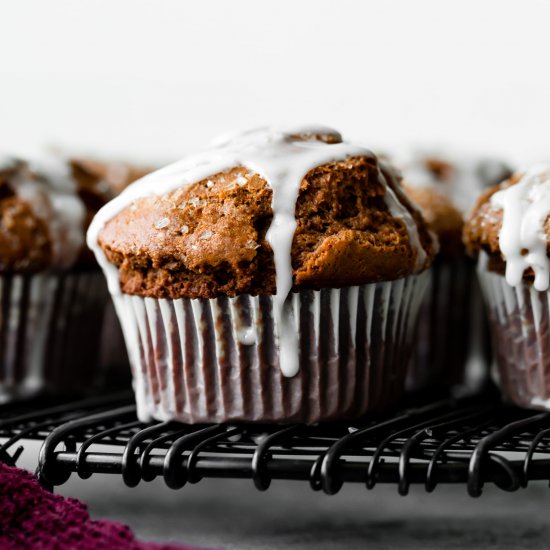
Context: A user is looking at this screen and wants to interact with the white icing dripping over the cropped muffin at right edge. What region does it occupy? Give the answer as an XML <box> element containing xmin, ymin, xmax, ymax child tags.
<box><xmin>491</xmin><ymin>165</ymin><xmax>550</xmax><ymax>291</ymax></box>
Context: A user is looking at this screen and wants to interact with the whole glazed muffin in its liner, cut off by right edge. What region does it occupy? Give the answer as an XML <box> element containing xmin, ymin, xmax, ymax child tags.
<box><xmin>464</xmin><ymin>165</ymin><xmax>550</xmax><ymax>410</ymax></box>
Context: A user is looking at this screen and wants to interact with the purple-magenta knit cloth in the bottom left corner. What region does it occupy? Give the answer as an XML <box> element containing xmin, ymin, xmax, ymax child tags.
<box><xmin>0</xmin><ymin>463</ymin><xmax>213</xmax><ymax>550</ymax></box>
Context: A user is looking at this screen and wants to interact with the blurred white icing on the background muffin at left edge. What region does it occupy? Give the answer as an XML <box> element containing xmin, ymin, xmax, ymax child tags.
<box><xmin>0</xmin><ymin>156</ymin><xmax>86</xmax><ymax>269</ymax></box>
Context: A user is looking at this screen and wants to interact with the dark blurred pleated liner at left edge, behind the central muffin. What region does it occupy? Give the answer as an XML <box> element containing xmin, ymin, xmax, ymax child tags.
<box><xmin>0</xmin><ymin>272</ymin><xmax>108</xmax><ymax>401</ymax></box>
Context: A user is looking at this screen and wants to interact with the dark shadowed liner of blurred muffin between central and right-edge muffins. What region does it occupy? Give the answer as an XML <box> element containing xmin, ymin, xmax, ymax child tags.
<box><xmin>407</xmin><ymin>256</ymin><xmax>490</xmax><ymax>391</ymax></box>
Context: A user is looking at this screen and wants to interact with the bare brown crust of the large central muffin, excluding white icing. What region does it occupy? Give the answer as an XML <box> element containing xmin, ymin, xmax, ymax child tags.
<box><xmin>99</xmin><ymin>157</ymin><xmax>434</xmax><ymax>298</ymax></box>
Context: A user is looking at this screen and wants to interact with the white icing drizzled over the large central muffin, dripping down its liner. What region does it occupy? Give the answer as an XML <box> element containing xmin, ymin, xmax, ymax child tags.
<box><xmin>88</xmin><ymin>126</ymin><xmax>426</xmax><ymax>377</ymax></box>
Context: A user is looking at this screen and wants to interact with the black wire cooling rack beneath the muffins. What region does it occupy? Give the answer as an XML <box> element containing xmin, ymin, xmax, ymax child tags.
<box><xmin>0</xmin><ymin>393</ymin><xmax>550</xmax><ymax>496</ymax></box>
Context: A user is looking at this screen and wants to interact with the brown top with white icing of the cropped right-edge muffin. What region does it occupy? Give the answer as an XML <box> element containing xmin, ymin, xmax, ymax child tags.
<box><xmin>464</xmin><ymin>165</ymin><xmax>550</xmax><ymax>291</ymax></box>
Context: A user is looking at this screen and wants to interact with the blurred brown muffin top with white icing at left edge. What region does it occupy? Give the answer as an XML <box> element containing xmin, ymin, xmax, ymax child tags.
<box><xmin>0</xmin><ymin>155</ymin><xmax>149</xmax><ymax>273</ymax></box>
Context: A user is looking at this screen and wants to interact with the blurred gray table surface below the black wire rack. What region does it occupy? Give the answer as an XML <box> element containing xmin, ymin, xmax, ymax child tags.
<box><xmin>15</xmin><ymin>444</ymin><xmax>550</xmax><ymax>550</ymax></box>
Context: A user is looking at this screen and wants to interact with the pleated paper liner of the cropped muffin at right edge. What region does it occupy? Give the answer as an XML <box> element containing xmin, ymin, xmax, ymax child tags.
<box><xmin>478</xmin><ymin>261</ymin><xmax>550</xmax><ymax>410</ymax></box>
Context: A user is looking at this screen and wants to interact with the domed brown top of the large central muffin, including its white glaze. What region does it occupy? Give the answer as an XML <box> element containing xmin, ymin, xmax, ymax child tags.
<box><xmin>92</xmin><ymin>127</ymin><xmax>442</xmax><ymax>302</ymax></box>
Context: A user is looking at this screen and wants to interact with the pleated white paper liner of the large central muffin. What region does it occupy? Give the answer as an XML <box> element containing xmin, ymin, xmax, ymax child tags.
<box><xmin>115</xmin><ymin>273</ymin><xmax>427</xmax><ymax>423</ymax></box>
